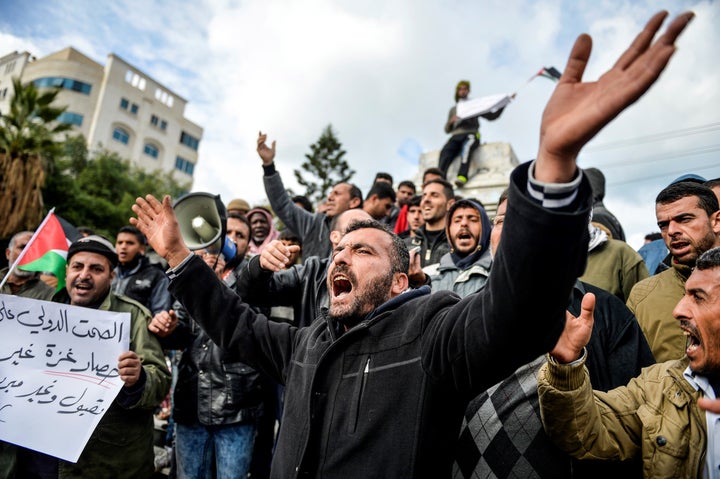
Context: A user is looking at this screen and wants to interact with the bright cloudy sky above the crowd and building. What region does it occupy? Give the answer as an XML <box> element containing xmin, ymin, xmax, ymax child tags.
<box><xmin>0</xmin><ymin>0</ymin><xmax>720</xmax><ymax>247</ymax></box>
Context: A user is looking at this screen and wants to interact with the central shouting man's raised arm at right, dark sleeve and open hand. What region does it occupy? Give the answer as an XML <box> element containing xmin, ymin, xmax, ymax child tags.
<box><xmin>425</xmin><ymin>9</ymin><xmax>692</xmax><ymax>395</ymax></box>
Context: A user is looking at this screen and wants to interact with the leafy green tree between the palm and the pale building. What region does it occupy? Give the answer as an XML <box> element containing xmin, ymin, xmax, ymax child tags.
<box><xmin>44</xmin><ymin>136</ymin><xmax>189</xmax><ymax>238</ymax></box>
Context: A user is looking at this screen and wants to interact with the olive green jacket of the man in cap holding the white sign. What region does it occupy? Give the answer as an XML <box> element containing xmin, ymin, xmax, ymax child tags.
<box><xmin>53</xmin><ymin>290</ymin><xmax>170</xmax><ymax>479</ymax></box>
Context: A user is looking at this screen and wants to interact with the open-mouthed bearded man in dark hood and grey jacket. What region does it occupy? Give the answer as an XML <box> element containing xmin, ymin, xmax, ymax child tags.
<box><xmin>430</xmin><ymin>199</ymin><xmax>492</xmax><ymax>298</ymax></box>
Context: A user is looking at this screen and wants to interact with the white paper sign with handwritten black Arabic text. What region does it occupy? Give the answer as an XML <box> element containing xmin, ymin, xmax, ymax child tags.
<box><xmin>0</xmin><ymin>295</ymin><xmax>130</xmax><ymax>462</ymax></box>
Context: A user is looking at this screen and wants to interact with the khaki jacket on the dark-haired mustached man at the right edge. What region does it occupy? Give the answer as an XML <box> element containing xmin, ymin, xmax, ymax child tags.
<box><xmin>627</xmin><ymin>264</ymin><xmax>692</xmax><ymax>363</ymax></box>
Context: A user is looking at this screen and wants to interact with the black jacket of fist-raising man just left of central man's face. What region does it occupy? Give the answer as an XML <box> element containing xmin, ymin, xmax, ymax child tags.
<box><xmin>236</xmin><ymin>256</ymin><xmax>330</xmax><ymax>327</ymax></box>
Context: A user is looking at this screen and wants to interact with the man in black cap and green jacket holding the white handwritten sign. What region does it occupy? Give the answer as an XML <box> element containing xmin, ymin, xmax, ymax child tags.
<box><xmin>10</xmin><ymin>236</ymin><xmax>170</xmax><ymax>478</ymax></box>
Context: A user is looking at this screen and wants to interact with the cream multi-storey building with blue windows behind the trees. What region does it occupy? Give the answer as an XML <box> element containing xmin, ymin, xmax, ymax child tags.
<box><xmin>0</xmin><ymin>47</ymin><xmax>203</xmax><ymax>184</ymax></box>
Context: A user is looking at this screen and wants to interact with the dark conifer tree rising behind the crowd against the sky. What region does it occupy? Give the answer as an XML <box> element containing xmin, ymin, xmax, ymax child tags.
<box><xmin>293</xmin><ymin>125</ymin><xmax>355</xmax><ymax>203</ymax></box>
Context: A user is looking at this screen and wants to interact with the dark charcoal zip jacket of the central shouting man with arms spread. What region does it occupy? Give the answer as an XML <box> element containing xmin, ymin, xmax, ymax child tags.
<box><xmin>170</xmin><ymin>165</ymin><xmax>590</xmax><ymax>479</ymax></box>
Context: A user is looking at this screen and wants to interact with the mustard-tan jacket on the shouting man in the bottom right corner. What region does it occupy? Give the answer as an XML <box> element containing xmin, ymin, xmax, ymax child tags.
<box><xmin>538</xmin><ymin>359</ymin><xmax>707</xmax><ymax>479</ymax></box>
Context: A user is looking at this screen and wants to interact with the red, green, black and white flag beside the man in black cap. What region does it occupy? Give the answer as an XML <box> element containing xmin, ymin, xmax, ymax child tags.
<box><xmin>16</xmin><ymin>208</ymin><xmax>80</xmax><ymax>291</ymax></box>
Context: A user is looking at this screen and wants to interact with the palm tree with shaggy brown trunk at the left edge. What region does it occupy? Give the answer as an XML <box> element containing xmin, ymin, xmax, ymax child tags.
<box><xmin>0</xmin><ymin>78</ymin><xmax>72</xmax><ymax>238</ymax></box>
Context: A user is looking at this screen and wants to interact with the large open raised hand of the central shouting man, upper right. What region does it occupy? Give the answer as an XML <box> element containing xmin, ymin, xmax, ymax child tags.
<box><xmin>535</xmin><ymin>11</ymin><xmax>693</xmax><ymax>183</ymax></box>
